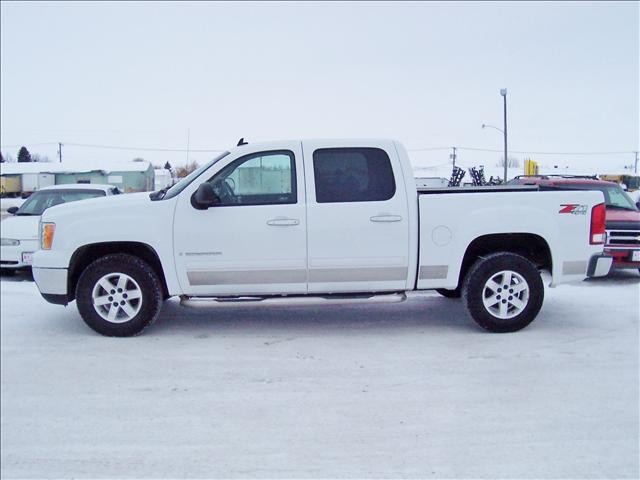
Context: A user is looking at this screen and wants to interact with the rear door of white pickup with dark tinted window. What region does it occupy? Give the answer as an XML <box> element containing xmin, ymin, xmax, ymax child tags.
<box><xmin>303</xmin><ymin>141</ymin><xmax>415</xmax><ymax>293</ymax></box>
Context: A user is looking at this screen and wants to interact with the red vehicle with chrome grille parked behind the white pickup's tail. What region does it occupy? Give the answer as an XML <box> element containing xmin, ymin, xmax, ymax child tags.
<box><xmin>510</xmin><ymin>175</ymin><xmax>640</xmax><ymax>271</ymax></box>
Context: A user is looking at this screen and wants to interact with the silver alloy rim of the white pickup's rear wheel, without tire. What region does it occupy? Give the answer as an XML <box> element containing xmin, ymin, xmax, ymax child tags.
<box><xmin>482</xmin><ymin>270</ymin><xmax>529</xmax><ymax>320</ymax></box>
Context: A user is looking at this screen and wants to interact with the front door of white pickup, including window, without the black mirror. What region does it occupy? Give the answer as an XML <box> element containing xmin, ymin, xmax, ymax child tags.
<box><xmin>174</xmin><ymin>142</ymin><xmax>307</xmax><ymax>296</ymax></box>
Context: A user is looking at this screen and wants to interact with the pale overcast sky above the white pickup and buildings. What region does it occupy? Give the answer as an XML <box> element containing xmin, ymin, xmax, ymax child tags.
<box><xmin>0</xmin><ymin>2</ymin><xmax>640</xmax><ymax>171</ymax></box>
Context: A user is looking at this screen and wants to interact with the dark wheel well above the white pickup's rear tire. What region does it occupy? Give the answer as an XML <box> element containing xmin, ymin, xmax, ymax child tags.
<box><xmin>458</xmin><ymin>233</ymin><xmax>552</xmax><ymax>285</ymax></box>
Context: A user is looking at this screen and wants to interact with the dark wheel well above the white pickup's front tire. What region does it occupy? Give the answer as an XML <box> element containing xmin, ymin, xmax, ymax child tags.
<box><xmin>67</xmin><ymin>242</ymin><xmax>169</xmax><ymax>301</ymax></box>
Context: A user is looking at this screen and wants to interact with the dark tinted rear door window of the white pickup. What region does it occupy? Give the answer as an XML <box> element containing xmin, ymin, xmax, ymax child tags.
<box><xmin>313</xmin><ymin>148</ymin><xmax>396</xmax><ymax>203</ymax></box>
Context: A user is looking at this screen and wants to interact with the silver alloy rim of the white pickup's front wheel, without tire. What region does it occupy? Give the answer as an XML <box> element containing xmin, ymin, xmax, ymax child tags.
<box><xmin>91</xmin><ymin>273</ymin><xmax>142</xmax><ymax>323</ymax></box>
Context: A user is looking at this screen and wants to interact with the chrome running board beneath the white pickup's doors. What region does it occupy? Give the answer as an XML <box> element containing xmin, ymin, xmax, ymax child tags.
<box><xmin>180</xmin><ymin>293</ymin><xmax>407</xmax><ymax>308</ymax></box>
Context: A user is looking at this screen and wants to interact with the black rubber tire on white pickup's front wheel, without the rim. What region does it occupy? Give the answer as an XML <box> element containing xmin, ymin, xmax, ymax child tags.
<box><xmin>76</xmin><ymin>254</ymin><xmax>162</xmax><ymax>337</ymax></box>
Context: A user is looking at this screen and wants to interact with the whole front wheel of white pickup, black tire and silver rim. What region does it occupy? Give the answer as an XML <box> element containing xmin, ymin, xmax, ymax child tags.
<box><xmin>76</xmin><ymin>254</ymin><xmax>162</xmax><ymax>337</ymax></box>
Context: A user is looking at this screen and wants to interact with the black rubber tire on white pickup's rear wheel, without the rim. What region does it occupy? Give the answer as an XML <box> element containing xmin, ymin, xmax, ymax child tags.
<box><xmin>462</xmin><ymin>252</ymin><xmax>544</xmax><ymax>333</ymax></box>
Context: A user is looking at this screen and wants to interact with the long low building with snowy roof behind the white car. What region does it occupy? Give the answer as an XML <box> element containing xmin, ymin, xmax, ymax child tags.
<box><xmin>0</xmin><ymin>161</ymin><xmax>155</xmax><ymax>196</ymax></box>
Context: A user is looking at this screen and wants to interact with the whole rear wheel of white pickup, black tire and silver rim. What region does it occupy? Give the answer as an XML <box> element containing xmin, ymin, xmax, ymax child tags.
<box><xmin>463</xmin><ymin>252</ymin><xmax>544</xmax><ymax>333</ymax></box>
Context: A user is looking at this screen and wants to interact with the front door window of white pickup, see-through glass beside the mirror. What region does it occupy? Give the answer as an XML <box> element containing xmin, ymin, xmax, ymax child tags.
<box><xmin>209</xmin><ymin>150</ymin><xmax>297</xmax><ymax>206</ymax></box>
